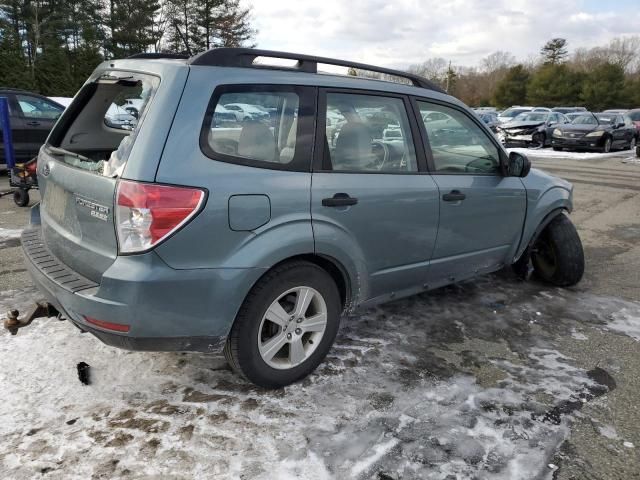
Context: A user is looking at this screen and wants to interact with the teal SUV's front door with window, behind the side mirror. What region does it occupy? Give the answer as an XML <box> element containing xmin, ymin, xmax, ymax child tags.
<box><xmin>417</xmin><ymin>101</ymin><xmax>526</xmax><ymax>284</ymax></box>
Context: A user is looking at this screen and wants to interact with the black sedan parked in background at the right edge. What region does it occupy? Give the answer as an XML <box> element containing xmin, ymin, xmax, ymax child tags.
<box><xmin>551</xmin><ymin>112</ymin><xmax>638</xmax><ymax>153</ymax></box>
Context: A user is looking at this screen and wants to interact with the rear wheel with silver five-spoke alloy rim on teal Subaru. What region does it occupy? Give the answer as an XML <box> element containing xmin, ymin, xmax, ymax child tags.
<box><xmin>224</xmin><ymin>261</ymin><xmax>342</xmax><ymax>388</ymax></box>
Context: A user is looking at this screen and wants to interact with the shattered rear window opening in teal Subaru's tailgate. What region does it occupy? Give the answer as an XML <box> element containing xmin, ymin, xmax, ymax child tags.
<box><xmin>48</xmin><ymin>71</ymin><xmax>160</xmax><ymax>177</ymax></box>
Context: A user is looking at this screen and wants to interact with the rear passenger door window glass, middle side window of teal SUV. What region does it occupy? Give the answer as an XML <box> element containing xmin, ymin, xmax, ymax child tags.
<box><xmin>323</xmin><ymin>93</ymin><xmax>418</xmax><ymax>173</ymax></box>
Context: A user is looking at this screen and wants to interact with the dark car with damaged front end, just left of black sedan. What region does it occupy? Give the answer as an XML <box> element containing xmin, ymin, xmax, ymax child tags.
<box><xmin>498</xmin><ymin>112</ymin><xmax>569</xmax><ymax>148</ymax></box>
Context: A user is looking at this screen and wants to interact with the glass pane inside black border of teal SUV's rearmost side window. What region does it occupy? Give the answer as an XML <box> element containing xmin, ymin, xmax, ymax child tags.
<box><xmin>208</xmin><ymin>88</ymin><xmax>300</xmax><ymax>166</ymax></box>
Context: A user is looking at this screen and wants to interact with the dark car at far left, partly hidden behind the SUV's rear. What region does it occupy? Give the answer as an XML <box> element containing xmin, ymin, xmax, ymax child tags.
<box><xmin>0</xmin><ymin>87</ymin><xmax>64</xmax><ymax>170</ymax></box>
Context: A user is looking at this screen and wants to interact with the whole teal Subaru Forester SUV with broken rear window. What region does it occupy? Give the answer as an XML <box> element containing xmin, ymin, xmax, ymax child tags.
<box><xmin>17</xmin><ymin>48</ymin><xmax>584</xmax><ymax>387</ymax></box>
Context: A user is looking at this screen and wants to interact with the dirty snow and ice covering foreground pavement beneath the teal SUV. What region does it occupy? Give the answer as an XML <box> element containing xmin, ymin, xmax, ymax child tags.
<box><xmin>0</xmin><ymin>275</ymin><xmax>640</xmax><ymax>480</ymax></box>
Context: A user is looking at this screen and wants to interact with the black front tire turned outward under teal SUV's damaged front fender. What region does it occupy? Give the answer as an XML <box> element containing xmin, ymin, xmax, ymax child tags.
<box><xmin>531</xmin><ymin>214</ymin><xmax>584</xmax><ymax>287</ymax></box>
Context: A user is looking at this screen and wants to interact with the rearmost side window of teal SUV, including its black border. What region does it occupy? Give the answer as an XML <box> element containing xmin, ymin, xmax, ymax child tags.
<box><xmin>200</xmin><ymin>85</ymin><xmax>314</xmax><ymax>170</ymax></box>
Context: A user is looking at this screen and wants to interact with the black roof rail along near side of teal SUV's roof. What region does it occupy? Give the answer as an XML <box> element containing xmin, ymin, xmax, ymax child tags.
<box><xmin>188</xmin><ymin>48</ymin><xmax>445</xmax><ymax>93</ymax></box>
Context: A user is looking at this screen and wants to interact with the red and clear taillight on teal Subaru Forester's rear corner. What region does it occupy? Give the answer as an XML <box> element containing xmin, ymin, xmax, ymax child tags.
<box><xmin>116</xmin><ymin>180</ymin><xmax>204</xmax><ymax>253</ymax></box>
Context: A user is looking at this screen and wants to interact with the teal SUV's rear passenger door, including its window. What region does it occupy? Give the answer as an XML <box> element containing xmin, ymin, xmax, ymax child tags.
<box><xmin>311</xmin><ymin>89</ymin><xmax>439</xmax><ymax>299</ymax></box>
